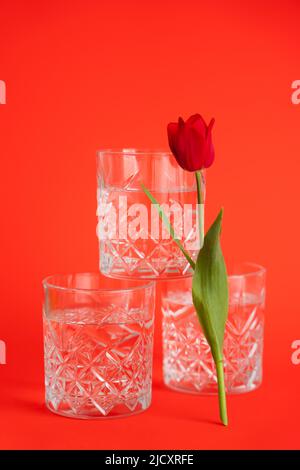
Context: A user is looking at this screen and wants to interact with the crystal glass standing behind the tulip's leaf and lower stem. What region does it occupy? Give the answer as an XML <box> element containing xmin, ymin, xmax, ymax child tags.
<box><xmin>161</xmin><ymin>263</ymin><xmax>266</xmax><ymax>394</ymax></box>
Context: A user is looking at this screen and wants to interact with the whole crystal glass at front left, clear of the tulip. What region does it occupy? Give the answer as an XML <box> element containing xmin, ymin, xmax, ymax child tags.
<box><xmin>43</xmin><ymin>273</ymin><xmax>155</xmax><ymax>418</ymax></box>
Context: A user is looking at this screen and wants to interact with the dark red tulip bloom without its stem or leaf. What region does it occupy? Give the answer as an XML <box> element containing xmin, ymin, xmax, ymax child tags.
<box><xmin>168</xmin><ymin>114</ymin><xmax>215</xmax><ymax>171</ymax></box>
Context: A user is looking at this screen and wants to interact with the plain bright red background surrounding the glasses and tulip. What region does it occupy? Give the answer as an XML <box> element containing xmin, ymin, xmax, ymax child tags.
<box><xmin>0</xmin><ymin>0</ymin><xmax>300</xmax><ymax>449</ymax></box>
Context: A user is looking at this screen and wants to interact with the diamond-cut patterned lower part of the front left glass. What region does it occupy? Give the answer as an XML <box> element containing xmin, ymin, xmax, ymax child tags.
<box><xmin>44</xmin><ymin>305</ymin><xmax>153</xmax><ymax>418</ymax></box>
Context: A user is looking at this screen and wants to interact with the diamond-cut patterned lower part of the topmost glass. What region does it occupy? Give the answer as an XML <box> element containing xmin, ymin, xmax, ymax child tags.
<box><xmin>97</xmin><ymin>188</ymin><xmax>199</xmax><ymax>278</ymax></box>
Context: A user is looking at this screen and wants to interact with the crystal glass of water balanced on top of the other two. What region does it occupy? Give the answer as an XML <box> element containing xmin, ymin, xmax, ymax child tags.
<box><xmin>97</xmin><ymin>149</ymin><xmax>205</xmax><ymax>279</ymax></box>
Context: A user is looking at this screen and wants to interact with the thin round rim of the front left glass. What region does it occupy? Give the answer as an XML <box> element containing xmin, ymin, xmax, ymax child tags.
<box><xmin>42</xmin><ymin>271</ymin><xmax>155</xmax><ymax>294</ymax></box>
